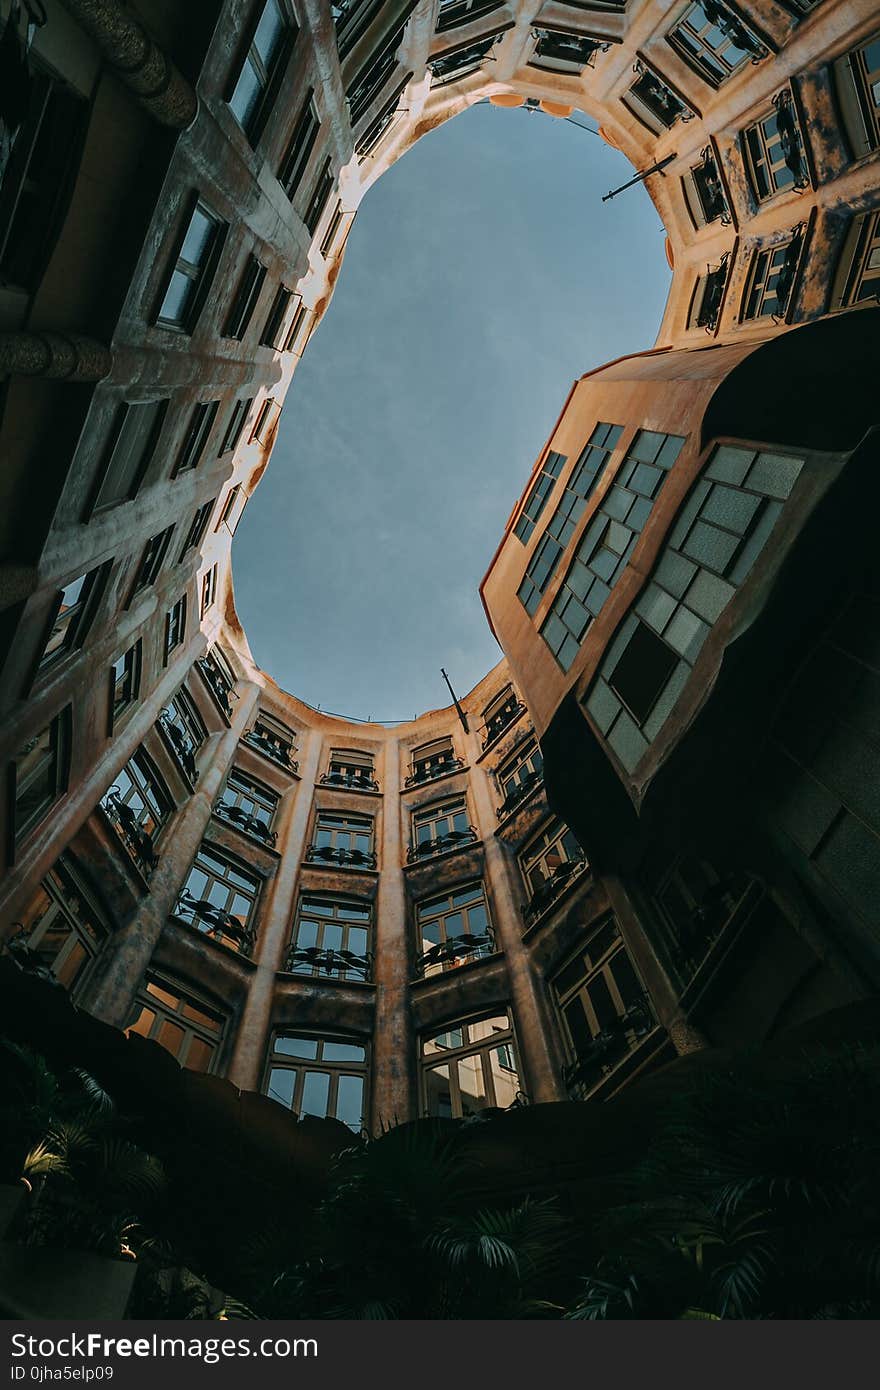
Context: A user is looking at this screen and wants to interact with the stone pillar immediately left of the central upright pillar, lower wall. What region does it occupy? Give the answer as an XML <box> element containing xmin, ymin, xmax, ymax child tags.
<box><xmin>227</xmin><ymin>730</ymin><xmax>321</xmax><ymax>1091</ymax></box>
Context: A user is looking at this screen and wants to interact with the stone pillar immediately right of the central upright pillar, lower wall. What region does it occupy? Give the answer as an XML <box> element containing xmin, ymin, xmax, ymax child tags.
<box><xmin>468</xmin><ymin>733</ymin><xmax>564</xmax><ymax>1104</ymax></box>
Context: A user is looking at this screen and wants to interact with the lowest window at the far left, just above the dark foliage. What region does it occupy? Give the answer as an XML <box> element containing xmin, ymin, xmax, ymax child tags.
<box><xmin>10</xmin><ymin>855</ymin><xmax>108</xmax><ymax>999</ymax></box>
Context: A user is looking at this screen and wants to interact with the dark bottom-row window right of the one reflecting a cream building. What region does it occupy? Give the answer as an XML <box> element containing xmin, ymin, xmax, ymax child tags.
<box><xmin>553</xmin><ymin>922</ymin><xmax>655</xmax><ymax>1099</ymax></box>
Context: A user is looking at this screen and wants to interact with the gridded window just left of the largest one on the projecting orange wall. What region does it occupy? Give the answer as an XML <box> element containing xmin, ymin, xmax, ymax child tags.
<box><xmin>541</xmin><ymin>430</ymin><xmax>684</xmax><ymax>671</ymax></box>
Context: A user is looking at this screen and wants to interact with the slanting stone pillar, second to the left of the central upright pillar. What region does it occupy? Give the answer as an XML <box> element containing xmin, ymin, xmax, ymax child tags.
<box><xmin>89</xmin><ymin>682</ymin><xmax>260</xmax><ymax>1027</ymax></box>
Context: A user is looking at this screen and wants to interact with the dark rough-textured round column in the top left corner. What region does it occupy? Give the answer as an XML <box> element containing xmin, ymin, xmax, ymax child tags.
<box><xmin>61</xmin><ymin>0</ymin><xmax>199</xmax><ymax>131</ymax></box>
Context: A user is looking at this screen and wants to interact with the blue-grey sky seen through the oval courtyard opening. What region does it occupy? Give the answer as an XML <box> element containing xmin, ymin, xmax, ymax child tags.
<box><xmin>232</xmin><ymin>104</ymin><xmax>670</xmax><ymax>723</ymax></box>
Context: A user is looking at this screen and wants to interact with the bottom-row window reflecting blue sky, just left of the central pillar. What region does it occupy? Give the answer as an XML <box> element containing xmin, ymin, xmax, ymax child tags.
<box><xmin>266</xmin><ymin>1033</ymin><xmax>367</xmax><ymax>1133</ymax></box>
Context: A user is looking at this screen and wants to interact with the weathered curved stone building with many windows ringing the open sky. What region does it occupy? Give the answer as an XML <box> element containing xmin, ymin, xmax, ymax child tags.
<box><xmin>0</xmin><ymin>0</ymin><xmax>880</xmax><ymax>1130</ymax></box>
